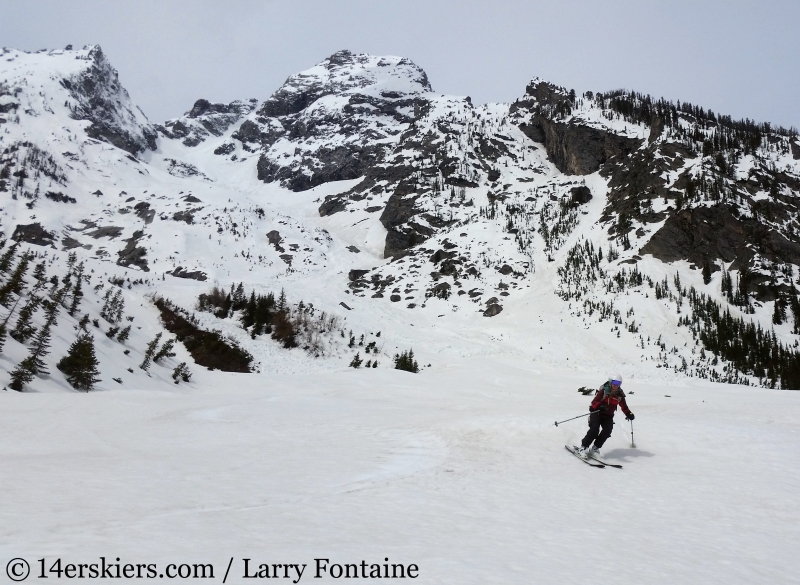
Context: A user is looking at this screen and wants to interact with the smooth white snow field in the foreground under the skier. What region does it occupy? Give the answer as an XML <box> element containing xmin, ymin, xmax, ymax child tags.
<box><xmin>0</xmin><ymin>357</ymin><xmax>800</xmax><ymax>584</ymax></box>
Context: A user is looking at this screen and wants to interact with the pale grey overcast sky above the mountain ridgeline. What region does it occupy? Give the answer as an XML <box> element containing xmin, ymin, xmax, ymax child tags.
<box><xmin>0</xmin><ymin>0</ymin><xmax>800</xmax><ymax>127</ymax></box>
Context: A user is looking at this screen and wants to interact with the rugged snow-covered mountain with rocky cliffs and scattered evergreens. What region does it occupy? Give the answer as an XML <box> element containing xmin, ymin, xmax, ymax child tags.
<box><xmin>0</xmin><ymin>47</ymin><xmax>800</xmax><ymax>390</ymax></box>
